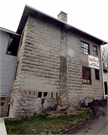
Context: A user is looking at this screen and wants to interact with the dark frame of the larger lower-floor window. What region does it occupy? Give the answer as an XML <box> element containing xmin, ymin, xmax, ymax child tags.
<box><xmin>82</xmin><ymin>66</ymin><xmax>92</xmax><ymax>85</ymax></box>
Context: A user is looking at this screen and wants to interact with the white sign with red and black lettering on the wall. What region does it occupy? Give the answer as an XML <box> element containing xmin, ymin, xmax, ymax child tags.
<box><xmin>88</xmin><ymin>55</ymin><xmax>99</xmax><ymax>69</ymax></box>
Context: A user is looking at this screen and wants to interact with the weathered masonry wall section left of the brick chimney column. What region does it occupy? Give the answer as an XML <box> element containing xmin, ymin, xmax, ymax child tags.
<box><xmin>10</xmin><ymin>17</ymin><xmax>60</xmax><ymax>116</ymax></box>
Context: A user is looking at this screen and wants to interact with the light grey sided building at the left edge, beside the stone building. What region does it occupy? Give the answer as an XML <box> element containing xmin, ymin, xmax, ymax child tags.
<box><xmin>0</xmin><ymin>28</ymin><xmax>20</xmax><ymax>117</ymax></box>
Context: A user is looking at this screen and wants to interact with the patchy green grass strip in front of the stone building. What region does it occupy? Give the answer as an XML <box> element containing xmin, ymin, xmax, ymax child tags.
<box><xmin>5</xmin><ymin>109</ymin><xmax>93</xmax><ymax>134</ymax></box>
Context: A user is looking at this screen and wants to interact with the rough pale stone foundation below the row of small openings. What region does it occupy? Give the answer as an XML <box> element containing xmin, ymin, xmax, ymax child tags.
<box><xmin>10</xmin><ymin>93</ymin><xmax>57</xmax><ymax>117</ymax></box>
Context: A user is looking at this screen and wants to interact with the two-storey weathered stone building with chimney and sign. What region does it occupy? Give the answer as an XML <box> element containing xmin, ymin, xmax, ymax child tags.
<box><xmin>2</xmin><ymin>6</ymin><xmax>106</xmax><ymax>117</ymax></box>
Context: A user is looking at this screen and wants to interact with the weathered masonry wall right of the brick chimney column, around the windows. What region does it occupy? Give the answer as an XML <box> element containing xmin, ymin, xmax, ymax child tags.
<box><xmin>67</xmin><ymin>33</ymin><xmax>103</xmax><ymax>106</ymax></box>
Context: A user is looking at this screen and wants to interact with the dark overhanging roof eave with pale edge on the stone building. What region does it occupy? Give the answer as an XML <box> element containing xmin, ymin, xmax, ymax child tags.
<box><xmin>17</xmin><ymin>5</ymin><xmax>108</xmax><ymax>45</ymax></box>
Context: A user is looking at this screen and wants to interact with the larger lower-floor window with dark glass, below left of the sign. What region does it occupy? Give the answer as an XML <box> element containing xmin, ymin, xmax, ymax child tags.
<box><xmin>82</xmin><ymin>67</ymin><xmax>91</xmax><ymax>84</ymax></box>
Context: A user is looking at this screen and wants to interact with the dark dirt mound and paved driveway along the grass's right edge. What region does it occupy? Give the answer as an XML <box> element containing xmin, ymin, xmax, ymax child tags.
<box><xmin>61</xmin><ymin>99</ymin><xmax>108</xmax><ymax>135</ymax></box>
